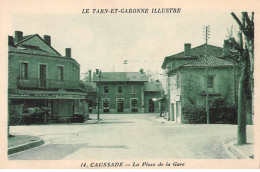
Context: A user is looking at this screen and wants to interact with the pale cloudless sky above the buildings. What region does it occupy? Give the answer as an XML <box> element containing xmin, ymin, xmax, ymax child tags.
<box><xmin>8</xmin><ymin>10</ymin><xmax>238</xmax><ymax>78</ymax></box>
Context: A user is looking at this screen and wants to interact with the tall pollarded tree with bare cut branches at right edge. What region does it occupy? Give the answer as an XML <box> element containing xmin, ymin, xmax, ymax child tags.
<box><xmin>225</xmin><ymin>12</ymin><xmax>254</xmax><ymax>145</ymax></box>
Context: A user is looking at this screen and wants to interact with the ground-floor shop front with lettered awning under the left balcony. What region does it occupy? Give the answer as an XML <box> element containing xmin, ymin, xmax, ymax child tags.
<box><xmin>8</xmin><ymin>90</ymin><xmax>87</xmax><ymax>123</ymax></box>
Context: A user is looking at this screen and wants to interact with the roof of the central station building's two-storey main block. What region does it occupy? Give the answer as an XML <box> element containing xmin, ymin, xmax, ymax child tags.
<box><xmin>93</xmin><ymin>72</ymin><xmax>147</xmax><ymax>82</ymax></box>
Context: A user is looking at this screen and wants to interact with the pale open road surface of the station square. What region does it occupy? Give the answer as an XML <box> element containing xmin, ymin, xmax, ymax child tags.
<box><xmin>9</xmin><ymin>114</ymin><xmax>251</xmax><ymax>160</ymax></box>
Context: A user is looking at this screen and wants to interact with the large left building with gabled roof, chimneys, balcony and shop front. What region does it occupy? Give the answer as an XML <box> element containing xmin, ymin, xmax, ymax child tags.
<box><xmin>8</xmin><ymin>31</ymin><xmax>86</xmax><ymax>120</ymax></box>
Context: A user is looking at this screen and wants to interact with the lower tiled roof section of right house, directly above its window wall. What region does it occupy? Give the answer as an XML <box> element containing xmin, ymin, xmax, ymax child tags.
<box><xmin>182</xmin><ymin>56</ymin><xmax>233</xmax><ymax>67</ymax></box>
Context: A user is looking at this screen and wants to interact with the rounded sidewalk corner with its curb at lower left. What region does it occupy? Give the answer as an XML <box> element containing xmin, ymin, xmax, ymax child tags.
<box><xmin>8</xmin><ymin>135</ymin><xmax>44</xmax><ymax>155</ymax></box>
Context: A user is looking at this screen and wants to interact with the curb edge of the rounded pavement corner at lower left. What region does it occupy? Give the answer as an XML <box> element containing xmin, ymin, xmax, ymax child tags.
<box><xmin>7</xmin><ymin>139</ymin><xmax>44</xmax><ymax>155</ymax></box>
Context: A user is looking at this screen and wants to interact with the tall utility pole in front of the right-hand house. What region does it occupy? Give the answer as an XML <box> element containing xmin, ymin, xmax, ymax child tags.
<box><xmin>203</xmin><ymin>26</ymin><xmax>210</xmax><ymax>124</ymax></box>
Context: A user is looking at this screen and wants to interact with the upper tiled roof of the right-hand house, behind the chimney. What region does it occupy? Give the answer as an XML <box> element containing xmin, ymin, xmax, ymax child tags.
<box><xmin>161</xmin><ymin>44</ymin><xmax>223</xmax><ymax>69</ymax></box>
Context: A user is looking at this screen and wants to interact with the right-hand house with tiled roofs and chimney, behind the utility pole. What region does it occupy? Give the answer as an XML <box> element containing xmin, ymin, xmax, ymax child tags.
<box><xmin>162</xmin><ymin>44</ymin><xmax>238</xmax><ymax>122</ymax></box>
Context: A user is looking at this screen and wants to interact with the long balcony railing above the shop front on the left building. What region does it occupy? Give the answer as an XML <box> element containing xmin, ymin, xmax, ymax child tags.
<box><xmin>17</xmin><ymin>78</ymin><xmax>84</xmax><ymax>89</ymax></box>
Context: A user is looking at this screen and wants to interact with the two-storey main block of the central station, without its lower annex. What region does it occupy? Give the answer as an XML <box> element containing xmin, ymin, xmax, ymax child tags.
<box><xmin>93</xmin><ymin>70</ymin><xmax>147</xmax><ymax>113</ymax></box>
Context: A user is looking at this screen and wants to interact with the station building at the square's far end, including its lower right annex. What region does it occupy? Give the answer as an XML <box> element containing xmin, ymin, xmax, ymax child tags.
<box><xmin>93</xmin><ymin>69</ymin><xmax>161</xmax><ymax>113</ymax></box>
